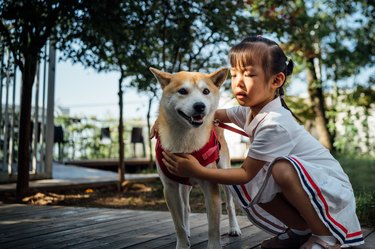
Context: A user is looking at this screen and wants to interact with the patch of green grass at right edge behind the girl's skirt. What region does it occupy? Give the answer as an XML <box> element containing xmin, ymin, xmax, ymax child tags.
<box><xmin>336</xmin><ymin>155</ymin><xmax>375</xmax><ymax>227</ymax></box>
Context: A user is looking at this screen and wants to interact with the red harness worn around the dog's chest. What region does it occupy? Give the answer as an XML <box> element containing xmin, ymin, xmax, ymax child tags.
<box><xmin>155</xmin><ymin>129</ymin><xmax>220</xmax><ymax>185</ymax></box>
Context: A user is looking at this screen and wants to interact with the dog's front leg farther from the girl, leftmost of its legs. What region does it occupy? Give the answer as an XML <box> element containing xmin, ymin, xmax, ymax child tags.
<box><xmin>163</xmin><ymin>179</ymin><xmax>191</xmax><ymax>249</ymax></box>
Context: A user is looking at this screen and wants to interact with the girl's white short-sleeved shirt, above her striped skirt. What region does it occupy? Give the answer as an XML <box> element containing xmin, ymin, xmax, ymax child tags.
<box><xmin>227</xmin><ymin>98</ymin><xmax>341</xmax><ymax>175</ymax></box>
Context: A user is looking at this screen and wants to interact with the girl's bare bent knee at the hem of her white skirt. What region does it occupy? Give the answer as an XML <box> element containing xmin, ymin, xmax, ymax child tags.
<box><xmin>272</xmin><ymin>160</ymin><xmax>298</xmax><ymax>186</ymax></box>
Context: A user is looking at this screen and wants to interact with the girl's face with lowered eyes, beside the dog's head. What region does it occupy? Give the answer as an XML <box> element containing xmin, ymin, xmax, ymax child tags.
<box><xmin>230</xmin><ymin>65</ymin><xmax>275</xmax><ymax>110</ymax></box>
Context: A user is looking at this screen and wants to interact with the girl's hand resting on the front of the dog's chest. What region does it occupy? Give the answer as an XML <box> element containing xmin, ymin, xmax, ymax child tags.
<box><xmin>162</xmin><ymin>151</ymin><xmax>203</xmax><ymax>177</ymax></box>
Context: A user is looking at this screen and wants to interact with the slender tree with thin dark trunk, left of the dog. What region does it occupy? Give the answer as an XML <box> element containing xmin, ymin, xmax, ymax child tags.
<box><xmin>59</xmin><ymin>0</ymin><xmax>154</xmax><ymax>189</ymax></box>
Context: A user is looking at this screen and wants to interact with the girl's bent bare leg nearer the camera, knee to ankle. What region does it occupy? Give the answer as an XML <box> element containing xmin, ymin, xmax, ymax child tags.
<box><xmin>272</xmin><ymin>160</ymin><xmax>332</xmax><ymax>235</ymax></box>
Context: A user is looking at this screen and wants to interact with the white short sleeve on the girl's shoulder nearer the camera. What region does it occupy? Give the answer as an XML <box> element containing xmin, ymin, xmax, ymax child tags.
<box><xmin>248</xmin><ymin>125</ymin><xmax>294</xmax><ymax>162</ymax></box>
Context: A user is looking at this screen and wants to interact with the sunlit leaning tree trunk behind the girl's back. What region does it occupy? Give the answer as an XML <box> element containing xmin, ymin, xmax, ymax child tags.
<box><xmin>307</xmin><ymin>58</ymin><xmax>333</xmax><ymax>150</ymax></box>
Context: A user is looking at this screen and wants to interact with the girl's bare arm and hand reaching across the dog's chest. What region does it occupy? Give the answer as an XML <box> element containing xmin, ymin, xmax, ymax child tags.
<box><xmin>163</xmin><ymin>151</ymin><xmax>265</xmax><ymax>185</ymax></box>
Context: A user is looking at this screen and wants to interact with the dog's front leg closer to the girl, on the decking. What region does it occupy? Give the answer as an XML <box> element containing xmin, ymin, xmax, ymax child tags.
<box><xmin>199</xmin><ymin>181</ymin><xmax>221</xmax><ymax>249</ymax></box>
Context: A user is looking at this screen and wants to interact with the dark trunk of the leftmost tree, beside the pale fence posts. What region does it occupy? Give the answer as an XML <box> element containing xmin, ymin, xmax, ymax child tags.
<box><xmin>17</xmin><ymin>55</ymin><xmax>37</xmax><ymax>200</ymax></box>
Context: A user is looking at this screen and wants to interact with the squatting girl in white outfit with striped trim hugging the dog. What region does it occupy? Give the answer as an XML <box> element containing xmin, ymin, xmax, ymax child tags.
<box><xmin>159</xmin><ymin>36</ymin><xmax>363</xmax><ymax>249</ymax></box>
